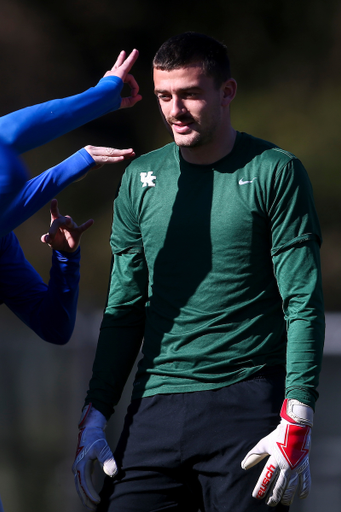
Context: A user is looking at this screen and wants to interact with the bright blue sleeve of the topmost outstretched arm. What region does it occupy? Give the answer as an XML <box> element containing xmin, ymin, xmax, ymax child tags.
<box><xmin>0</xmin><ymin>76</ymin><xmax>123</xmax><ymax>154</ymax></box>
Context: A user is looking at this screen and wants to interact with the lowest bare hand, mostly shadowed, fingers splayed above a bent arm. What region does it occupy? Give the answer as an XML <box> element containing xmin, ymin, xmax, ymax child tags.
<box><xmin>40</xmin><ymin>199</ymin><xmax>94</xmax><ymax>252</ymax></box>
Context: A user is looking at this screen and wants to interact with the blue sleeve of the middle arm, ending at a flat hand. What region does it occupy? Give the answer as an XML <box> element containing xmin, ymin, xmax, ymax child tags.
<box><xmin>0</xmin><ymin>149</ymin><xmax>95</xmax><ymax>236</ymax></box>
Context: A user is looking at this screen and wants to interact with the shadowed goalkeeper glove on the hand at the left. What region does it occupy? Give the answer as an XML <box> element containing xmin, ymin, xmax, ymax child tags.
<box><xmin>72</xmin><ymin>404</ymin><xmax>117</xmax><ymax>510</ymax></box>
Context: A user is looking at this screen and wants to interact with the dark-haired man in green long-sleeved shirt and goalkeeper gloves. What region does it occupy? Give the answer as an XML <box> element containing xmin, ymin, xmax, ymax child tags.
<box><xmin>73</xmin><ymin>32</ymin><xmax>324</xmax><ymax>512</ymax></box>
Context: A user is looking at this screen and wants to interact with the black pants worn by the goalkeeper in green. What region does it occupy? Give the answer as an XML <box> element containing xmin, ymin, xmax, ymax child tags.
<box><xmin>97</xmin><ymin>367</ymin><xmax>289</xmax><ymax>512</ymax></box>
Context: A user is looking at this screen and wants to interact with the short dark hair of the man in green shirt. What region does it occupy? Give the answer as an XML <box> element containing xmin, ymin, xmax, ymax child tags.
<box><xmin>153</xmin><ymin>32</ymin><xmax>231</xmax><ymax>87</ymax></box>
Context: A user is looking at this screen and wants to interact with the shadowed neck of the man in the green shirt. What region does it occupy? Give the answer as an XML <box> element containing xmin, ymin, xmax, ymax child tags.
<box><xmin>180</xmin><ymin>126</ymin><xmax>237</xmax><ymax>165</ymax></box>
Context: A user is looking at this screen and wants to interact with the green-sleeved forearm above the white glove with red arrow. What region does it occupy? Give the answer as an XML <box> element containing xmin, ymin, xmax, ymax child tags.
<box><xmin>274</xmin><ymin>240</ymin><xmax>325</xmax><ymax>409</ymax></box>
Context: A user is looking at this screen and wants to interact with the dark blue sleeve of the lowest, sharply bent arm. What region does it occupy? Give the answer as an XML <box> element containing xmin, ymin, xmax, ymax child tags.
<box><xmin>0</xmin><ymin>233</ymin><xmax>80</xmax><ymax>345</ymax></box>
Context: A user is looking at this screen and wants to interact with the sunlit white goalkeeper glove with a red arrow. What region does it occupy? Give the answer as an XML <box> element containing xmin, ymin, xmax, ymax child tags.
<box><xmin>241</xmin><ymin>398</ymin><xmax>314</xmax><ymax>507</ymax></box>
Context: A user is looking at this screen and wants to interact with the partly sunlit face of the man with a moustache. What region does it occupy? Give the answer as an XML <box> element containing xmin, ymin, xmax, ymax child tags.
<box><xmin>154</xmin><ymin>65</ymin><xmax>224</xmax><ymax>148</ymax></box>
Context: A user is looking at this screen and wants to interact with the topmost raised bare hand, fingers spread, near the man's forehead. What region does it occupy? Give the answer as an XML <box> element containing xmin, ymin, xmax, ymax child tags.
<box><xmin>104</xmin><ymin>50</ymin><xmax>142</xmax><ymax>108</ymax></box>
